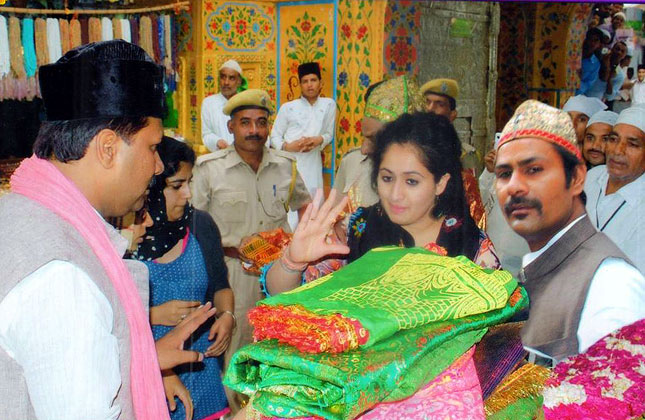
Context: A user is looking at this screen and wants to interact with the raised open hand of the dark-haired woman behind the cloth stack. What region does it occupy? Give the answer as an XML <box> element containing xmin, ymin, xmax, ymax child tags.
<box><xmin>289</xmin><ymin>189</ymin><xmax>349</xmax><ymax>264</ymax></box>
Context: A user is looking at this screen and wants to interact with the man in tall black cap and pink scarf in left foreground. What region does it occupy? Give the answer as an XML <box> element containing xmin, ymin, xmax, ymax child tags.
<box><xmin>0</xmin><ymin>41</ymin><xmax>214</xmax><ymax>420</ymax></box>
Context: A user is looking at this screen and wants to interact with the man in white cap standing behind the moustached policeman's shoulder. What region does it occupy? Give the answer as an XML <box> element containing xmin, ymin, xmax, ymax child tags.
<box><xmin>202</xmin><ymin>60</ymin><xmax>242</xmax><ymax>152</ymax></box>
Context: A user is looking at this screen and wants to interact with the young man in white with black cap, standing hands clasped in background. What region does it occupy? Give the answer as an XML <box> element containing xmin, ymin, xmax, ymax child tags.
<box><xmin>271</xmin><ymin>63</ymin><xmax>336</xmax><ymax>205</ymax></box>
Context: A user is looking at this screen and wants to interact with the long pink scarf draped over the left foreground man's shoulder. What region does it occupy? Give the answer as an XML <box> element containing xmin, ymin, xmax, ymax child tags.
<box><xmin>11</xmin><ymin>156</ymin><xmax>169</xmax><ymax>420</ymax></box>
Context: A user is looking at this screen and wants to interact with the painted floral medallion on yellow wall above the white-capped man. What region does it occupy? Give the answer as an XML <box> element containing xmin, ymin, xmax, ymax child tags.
<box><xmin>204</xmin><ymin>2</ymin><xmax>274</xmax><ymax>52</ymax></box>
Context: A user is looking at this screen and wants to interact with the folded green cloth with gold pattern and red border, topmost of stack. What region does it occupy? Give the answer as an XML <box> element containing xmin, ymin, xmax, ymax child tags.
<box><xmin>249</xmin><ymin>247</ymin><xmax>519</xmax><ymax>353</ymax></box>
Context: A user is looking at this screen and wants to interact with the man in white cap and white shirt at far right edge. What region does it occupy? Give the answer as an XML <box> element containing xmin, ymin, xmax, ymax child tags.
<box><xmin>585</xmin><ymin>106</ymin><xmax>645</xmax><ymax>272</ymax></box>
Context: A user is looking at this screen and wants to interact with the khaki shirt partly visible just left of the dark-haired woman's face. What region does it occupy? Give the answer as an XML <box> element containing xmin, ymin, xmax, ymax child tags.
<box><xmin>334</xmin><ymin>149</ymin><xmax>378</xmax><ymax>210</ymax></box>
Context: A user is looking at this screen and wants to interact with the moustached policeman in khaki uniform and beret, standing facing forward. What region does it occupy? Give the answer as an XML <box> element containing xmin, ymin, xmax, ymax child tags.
<box><xmin>191</xmin><ymin>89</ymin><xmax>311</xmax><ymax>406</ymax></box>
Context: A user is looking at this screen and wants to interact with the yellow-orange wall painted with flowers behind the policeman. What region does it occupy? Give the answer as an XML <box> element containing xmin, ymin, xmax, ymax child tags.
<box><xmin>179</xmin><ymin>0</ymin><xmax>388</xmax><ymax>173</ymax></box>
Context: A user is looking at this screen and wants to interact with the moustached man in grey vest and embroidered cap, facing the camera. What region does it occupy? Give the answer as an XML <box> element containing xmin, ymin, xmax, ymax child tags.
<box><xmin>495</xmin><ymin>100</ymin><xmax>645</xmax><ymax>363</ymax></box>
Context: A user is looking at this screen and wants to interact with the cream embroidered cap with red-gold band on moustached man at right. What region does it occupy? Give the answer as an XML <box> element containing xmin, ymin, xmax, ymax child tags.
<box><xmin>497</xmin><ymin>99</ymin><xmax>582</xmax><ymax>162</ymax></box>
